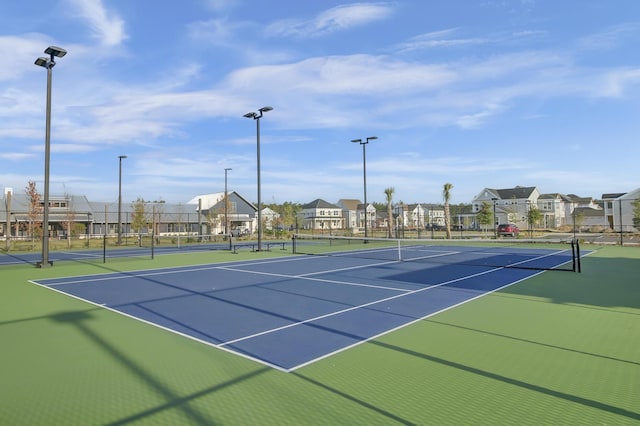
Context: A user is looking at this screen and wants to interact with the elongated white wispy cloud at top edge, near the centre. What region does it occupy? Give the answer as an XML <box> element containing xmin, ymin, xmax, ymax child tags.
<box><xmin>267</xmin><ymin>3</ymin><xmax>393</xmax><ymax>37</ymax></box>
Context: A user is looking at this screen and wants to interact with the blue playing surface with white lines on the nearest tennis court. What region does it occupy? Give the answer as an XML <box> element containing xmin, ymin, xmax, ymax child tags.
<box><xmin>35</xmin><ymin>246</ymin><xmax>566</xmax><ymax>371</ymax></box>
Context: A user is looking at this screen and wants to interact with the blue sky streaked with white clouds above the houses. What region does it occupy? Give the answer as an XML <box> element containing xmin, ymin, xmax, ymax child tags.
<box><xmin>0</xmin><ymin>0</ymin><xmax>640</xmax><ymax>203</ymax></box>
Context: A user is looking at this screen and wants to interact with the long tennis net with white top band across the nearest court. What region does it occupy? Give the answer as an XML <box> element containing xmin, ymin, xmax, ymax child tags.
<box><xmin>293</xmin><ymin>234</ymin><xmax>580</xmax><ymax>272</ymax></box>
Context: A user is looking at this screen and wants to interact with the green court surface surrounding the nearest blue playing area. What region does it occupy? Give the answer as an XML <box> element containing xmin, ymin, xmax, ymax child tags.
<box><xmin>0</xmin><ymin>246</ymin><xmax>640</xmax><ymax>425</ymax></box>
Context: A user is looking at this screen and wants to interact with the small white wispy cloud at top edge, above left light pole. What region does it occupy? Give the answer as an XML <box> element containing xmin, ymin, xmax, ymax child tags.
<box><xmin>67</xmin><ymin>0</ymin><xmax>128</xmax><ymax>46</ymax></box>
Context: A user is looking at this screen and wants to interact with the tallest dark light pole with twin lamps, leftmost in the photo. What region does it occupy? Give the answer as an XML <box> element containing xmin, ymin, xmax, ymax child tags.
<box><xmin>35</xmin><ymin>46</ymin><xmax>67</xmax><ymax>268</ymax></box>
